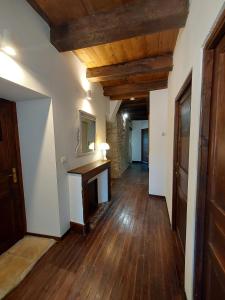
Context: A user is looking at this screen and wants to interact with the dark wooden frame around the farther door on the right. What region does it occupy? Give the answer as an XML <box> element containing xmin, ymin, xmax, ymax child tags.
<box><xmin>172</xmin><ymin>71</ymin><xmax>192</xmax><ymax>231</ymax></box>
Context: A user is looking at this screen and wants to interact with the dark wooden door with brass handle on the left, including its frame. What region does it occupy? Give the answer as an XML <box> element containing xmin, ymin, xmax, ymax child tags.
<box><xmin>0</xmin><ymin>100</ymin><xmax>26</xmax><ymax>253</ymax></box>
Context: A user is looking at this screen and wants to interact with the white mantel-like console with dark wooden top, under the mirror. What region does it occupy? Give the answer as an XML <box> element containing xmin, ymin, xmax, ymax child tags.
<box><xmin>68</xmin><ymin>160</ymin><xmax>111</xmax><ymax>233</ymax></box>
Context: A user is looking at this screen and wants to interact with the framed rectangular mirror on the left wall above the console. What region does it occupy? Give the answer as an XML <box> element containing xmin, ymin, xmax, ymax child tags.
<box><xmin>78</xmin><ymin>110</ymin><xmax>96</xmax><ymax>154</ymax></box>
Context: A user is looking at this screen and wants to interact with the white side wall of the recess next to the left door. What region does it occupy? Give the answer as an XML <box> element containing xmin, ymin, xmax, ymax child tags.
<box><xmin>17</xmin><ymin>99</ymin><xmax>60</xmax><ymax>236</ymax></box>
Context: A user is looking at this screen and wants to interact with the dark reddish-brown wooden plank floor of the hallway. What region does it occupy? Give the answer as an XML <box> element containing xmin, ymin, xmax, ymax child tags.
<box><xmin>6</xmin><ymin>164</ymin><xmax>182</xmax><ymax>300</ymax></box>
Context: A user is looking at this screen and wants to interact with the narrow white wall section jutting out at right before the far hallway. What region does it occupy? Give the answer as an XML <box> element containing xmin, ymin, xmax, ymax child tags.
<box><xmin>149</xmin><ymin>89</ymin><xmax>168</xmax><ymax>196</ymax></box>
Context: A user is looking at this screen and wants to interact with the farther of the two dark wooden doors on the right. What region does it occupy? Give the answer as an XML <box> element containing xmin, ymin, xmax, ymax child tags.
<box><xmin>173</xmin><ymin>79</ymin><xmax>191</xmax><ymax>284</ymax></box>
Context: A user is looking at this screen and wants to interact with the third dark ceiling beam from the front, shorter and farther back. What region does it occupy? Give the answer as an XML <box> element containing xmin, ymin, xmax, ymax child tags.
<box><xmin>104</xmin><ymin>80</ymin><xmax>167</xmax><ymax>97</ymax></box>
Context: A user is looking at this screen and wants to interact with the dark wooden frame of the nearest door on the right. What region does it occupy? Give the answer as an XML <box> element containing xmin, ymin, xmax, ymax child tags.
<box><xmin>194</xmin><ymin>10</ymin><xmax>225</xmax><ymax>300</ymax></box>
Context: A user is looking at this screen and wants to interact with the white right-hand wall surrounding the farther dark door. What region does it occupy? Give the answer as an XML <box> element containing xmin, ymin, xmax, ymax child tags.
<box><xmin>166</xmin><ymin>0</ymin><xmax>225</xmax><ymax>299</ymax></box>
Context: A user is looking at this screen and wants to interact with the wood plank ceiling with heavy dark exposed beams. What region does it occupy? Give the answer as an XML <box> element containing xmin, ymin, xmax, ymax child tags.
<box><xmin>27</xmin><ymin>0</ymin><xmax>188</xmax><ymax>119</ymax></box>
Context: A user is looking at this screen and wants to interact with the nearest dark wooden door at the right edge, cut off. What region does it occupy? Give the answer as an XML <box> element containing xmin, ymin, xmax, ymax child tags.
<box><xmin>203</xmin><ymin>34</ymin><xmax>225</xmax><ymax>300</ymax></box>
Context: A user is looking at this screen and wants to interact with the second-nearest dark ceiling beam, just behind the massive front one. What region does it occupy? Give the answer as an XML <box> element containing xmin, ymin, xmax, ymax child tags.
<box><xmin>87</xmin><ymin>53</ymin><xmax>173</xmax><ymax>82</ymax></box>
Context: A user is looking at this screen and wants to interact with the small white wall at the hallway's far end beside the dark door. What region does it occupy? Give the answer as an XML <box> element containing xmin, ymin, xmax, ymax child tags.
<box><xmin>131</xmin><ymin>120</ymin><xmax>148</xmax><ymax>161</ymax></box>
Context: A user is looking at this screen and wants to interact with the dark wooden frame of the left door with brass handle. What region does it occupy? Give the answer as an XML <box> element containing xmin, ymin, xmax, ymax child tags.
<box><xmin>0</xmin><ymin>98</ymin><xmax>27</xmax><ymax>238</ymax></box>
